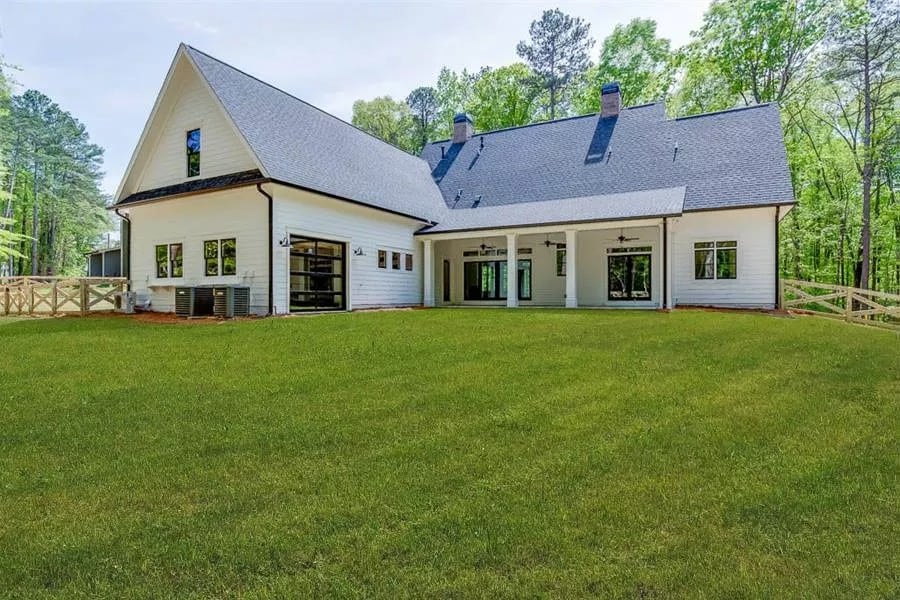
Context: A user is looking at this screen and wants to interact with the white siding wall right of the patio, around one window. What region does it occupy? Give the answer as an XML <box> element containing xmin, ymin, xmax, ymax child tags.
<box><xmin>672</xmin><ymin>207</ymin><xmax>775</xmax><ymax>307</ymax></box>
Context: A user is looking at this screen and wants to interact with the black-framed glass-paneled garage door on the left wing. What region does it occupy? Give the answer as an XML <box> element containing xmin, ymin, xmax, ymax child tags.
<box><xmin>290</xmin><ymin>235</ymin><xmax>347</xmax><ymax>312</ymax></box>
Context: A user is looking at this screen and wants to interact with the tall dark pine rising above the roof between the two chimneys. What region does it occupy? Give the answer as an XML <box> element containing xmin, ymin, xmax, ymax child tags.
<box><xmin>516</xmin><ymin>9</ymin><xmax>594</xmax><ymax>119</ymax></box>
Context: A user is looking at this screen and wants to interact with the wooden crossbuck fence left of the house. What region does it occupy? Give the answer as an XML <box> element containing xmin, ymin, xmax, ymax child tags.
<box><xmin>0</xmin><ymin>277</ymin><xmax>128</xmax><ymax>315</ymax></box>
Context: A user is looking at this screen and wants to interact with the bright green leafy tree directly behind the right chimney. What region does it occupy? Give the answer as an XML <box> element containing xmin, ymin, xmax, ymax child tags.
<box><xmin>573</xmin><ymin>19</ymin><xmax>673</xmax><ymax>114</ymax></box>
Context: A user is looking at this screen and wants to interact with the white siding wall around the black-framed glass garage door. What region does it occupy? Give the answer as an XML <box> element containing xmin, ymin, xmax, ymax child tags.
<box><xmin>272</xmin><ymin>185</ymin><xmax>423</xmax><ymax>313</ymax></box>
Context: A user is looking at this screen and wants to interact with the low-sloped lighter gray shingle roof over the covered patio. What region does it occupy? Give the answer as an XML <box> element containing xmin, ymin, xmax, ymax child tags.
<box><xmin>420</xmin><ymin>187</ymin><xmax>685</xmax><ymax>233</ymax></box>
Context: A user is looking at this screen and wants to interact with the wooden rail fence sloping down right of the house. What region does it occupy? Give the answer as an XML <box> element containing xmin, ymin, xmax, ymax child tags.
<box><xmin>781</xmin><ymin>279</ymin><xmax>900</xmax><ymax>330</ymax></box>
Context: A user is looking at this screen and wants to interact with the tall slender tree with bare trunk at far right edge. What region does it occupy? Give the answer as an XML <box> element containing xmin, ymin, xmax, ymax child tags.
<box><xmin>822</xmin><ymin>0</ymin><xmax>900</xmax><ymax>288</ymax></box>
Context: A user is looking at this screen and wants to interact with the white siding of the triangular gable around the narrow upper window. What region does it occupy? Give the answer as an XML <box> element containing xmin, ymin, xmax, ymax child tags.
<box><xmin>125</xmin><ymin>58</ymin><xmax>257</xmax><ymax>194</ymax></box>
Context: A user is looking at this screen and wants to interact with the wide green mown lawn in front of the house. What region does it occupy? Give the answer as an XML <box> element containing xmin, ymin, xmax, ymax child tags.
<box><xmin>0</xmin><ymin>309</ymin><xmax>900</xmax><ymax>599</ymax></box>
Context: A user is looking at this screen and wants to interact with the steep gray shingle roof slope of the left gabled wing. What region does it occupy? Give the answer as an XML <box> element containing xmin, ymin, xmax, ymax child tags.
<box><xmin>186</xmin><ymin>46</ymin><xmax>446</xmax><ymax>221</ymax></box>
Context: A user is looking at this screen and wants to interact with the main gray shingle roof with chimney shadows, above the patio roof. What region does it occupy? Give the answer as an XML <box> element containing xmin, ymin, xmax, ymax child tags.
<box><xmin>422</xmin><ymin>103</ymin><xmax>793</xmax><ymax>213</ymax></box>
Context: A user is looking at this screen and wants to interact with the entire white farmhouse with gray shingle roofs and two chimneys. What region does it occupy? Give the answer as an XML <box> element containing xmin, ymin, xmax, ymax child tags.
<box><xmin>114</xmin><ymin>45</ymin><xmax>793</xmax><ymax>314</ymax></box>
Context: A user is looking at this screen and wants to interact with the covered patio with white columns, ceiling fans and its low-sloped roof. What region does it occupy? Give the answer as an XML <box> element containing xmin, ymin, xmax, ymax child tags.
<box><xmin>419</xmin><ymin>188</ymin><xmax>684</xmax><ymax>308</ymax></box>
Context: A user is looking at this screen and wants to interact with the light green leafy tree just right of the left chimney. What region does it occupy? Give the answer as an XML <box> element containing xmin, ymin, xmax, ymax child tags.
<box><xmin>467</xmin><ymin>63</ymin><xmax>540</xmax><ymax>130</ymax></box>
